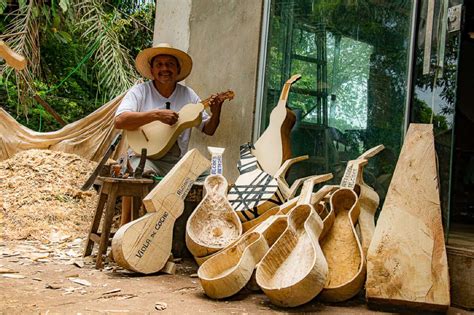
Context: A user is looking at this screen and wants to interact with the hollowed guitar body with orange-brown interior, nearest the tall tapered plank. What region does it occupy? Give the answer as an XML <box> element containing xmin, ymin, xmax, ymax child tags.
<box><xmin>320</xmin><ymin>188</ymin><xmax>366</xmax><ymax>302</ymax></box>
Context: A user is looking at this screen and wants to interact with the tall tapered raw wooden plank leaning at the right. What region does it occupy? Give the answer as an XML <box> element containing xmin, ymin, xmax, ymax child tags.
<box><xmin>366</xmin><ymin>124</ymin><xmax>450</xmax><ymax>311</ymax></box>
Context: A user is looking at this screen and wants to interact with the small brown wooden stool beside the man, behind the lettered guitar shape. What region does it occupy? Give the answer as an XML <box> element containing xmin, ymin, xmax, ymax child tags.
<box><xmin>84</xmin><ymin>177</ymin><xmax>154</xmax><ymax>269</ymax></box>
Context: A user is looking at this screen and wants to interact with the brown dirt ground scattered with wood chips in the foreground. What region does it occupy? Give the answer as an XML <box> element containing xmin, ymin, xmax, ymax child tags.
<box><xmin>0</xmin><ymin>243</ymin><xmax>467</xmax><ymax>314</ymax></box>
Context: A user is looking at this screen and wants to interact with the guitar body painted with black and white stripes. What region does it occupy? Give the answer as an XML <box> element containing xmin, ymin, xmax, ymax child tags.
<box><xmin>227</xmin><ymin>143</ymin><xmax>308</xmax><ymax>222</ymax></box>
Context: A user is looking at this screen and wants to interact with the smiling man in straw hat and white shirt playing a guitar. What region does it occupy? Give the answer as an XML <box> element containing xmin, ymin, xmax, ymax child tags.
<box><xmin>115</xmin><ymin>43</ymin><xmax>223</xmax><ymax>223</ymax></box>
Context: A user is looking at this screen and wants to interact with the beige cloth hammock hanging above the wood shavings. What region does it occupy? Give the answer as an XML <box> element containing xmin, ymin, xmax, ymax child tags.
<box><xmin>0</xmin><ymin>94</ymin><xmax>128</xmax><ymax>161</ymax></box>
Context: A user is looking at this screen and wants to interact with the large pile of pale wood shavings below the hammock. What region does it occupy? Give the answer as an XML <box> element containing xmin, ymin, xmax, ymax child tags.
<box><xmin>0</xmin><ymin>150</ymin><xmax>97</xmax><ymax>242</ymax></box>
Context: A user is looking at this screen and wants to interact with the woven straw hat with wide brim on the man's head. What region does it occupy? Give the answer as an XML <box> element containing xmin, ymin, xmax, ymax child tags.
<box><xmin>135</xmin><ymin>43</ymin><xmax>193</xmax><ymax>81</ymax></box>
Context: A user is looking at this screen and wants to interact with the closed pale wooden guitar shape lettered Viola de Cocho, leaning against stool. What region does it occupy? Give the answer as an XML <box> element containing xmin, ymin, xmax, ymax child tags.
<box><xmin>112</xmin><ymin>149</ymin><xmax>210</xmax><ymax>274</ymax></box>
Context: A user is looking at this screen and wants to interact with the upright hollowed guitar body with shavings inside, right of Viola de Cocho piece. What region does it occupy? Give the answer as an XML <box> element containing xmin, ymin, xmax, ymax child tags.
<box><xmin>186</xmin><ymin>147</ymin><xmax>242</xmax><ymax>257</ymax></box>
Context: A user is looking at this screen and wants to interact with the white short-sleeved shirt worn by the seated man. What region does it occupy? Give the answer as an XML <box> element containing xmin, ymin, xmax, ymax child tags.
<box><xmin>115</xmin><ymin>81</ymin><xmax>210</xmax><ymax>157</ymax></box>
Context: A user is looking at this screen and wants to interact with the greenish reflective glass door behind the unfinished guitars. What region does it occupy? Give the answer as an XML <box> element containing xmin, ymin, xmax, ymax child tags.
<box><xmin>260</xmin><ymin>0</ymin><xmax>414</xmax><ymax>199</ymax></box>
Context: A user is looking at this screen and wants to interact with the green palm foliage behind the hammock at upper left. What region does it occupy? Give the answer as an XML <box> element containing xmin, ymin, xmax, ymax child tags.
<box><xmin>0</xmin><ymin>0</ymin><xmax>154</xmax><ymax>131</ymax></box>
